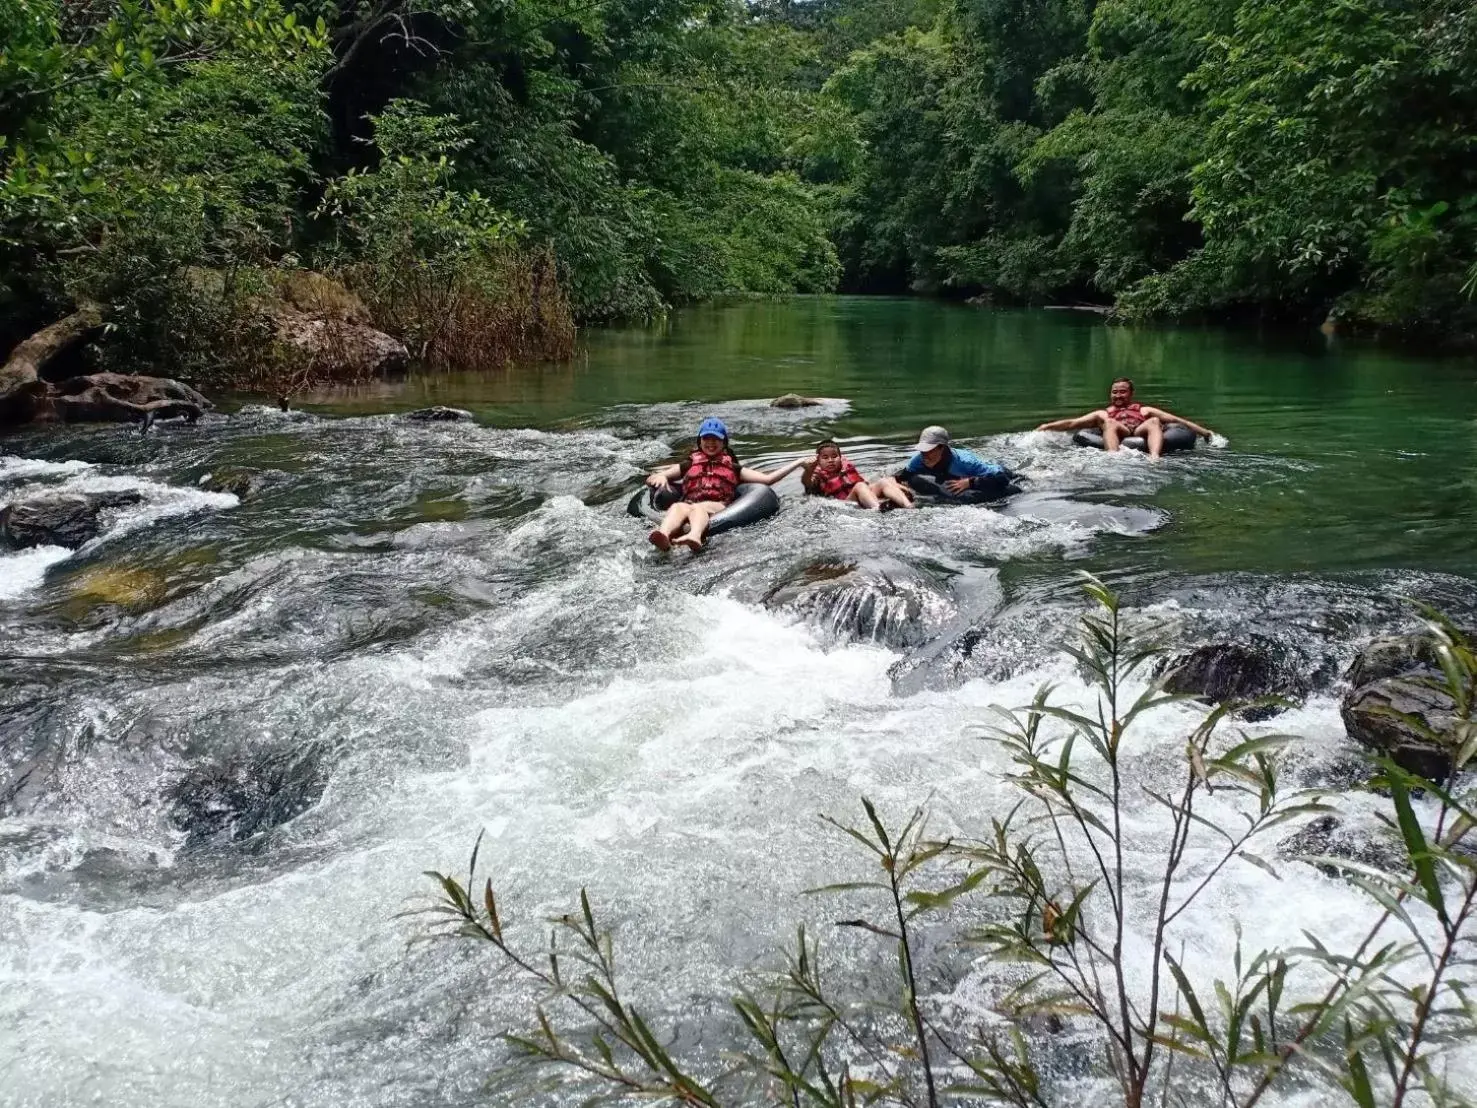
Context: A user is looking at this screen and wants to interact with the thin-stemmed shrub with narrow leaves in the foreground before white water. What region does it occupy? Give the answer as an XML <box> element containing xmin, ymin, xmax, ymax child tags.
<box><xmin>428</xmin><ymin>581</ymin><xmax>1477</xmax><ymax>1108</ymax></box>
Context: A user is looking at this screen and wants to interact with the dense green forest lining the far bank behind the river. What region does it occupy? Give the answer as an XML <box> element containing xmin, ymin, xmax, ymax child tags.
<box><xmin>0</xmin><ymin>0</ymin><xmax>1477</xmax><ymax>390</ymax></box>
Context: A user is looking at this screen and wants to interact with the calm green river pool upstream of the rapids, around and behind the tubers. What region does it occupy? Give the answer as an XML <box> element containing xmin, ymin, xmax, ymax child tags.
<box><xmin>308</xmin><ymin>297</ymin><xmax>1477</xmax><ymax>575</ymax></box>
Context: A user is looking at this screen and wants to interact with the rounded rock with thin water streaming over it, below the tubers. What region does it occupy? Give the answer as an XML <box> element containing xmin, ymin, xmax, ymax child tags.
<box><xmin>764</xmin><ymin>558</ymin><xmax>957</xmax><ymax>647</ymax></box>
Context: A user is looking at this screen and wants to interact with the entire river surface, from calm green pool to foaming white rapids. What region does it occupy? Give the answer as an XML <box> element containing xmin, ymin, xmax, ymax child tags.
<box><xmin>0</xmin><ymin>300</ymin><xmax>1477</xmax><ymax>1107</ymax></box>
